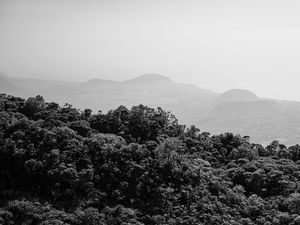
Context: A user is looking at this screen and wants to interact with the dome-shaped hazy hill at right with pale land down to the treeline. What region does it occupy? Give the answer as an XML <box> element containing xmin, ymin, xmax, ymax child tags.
<box><xmin>196</xmin><ymin>89</ymin><xmax>300</xmax><ymax>145</ymax></box>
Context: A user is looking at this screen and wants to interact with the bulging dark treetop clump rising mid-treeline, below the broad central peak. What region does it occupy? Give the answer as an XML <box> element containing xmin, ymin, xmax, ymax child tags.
<box><xmin>89</xmin><ymin>105</ymin><xmax>184</xmax><ymax>143</ymax></box>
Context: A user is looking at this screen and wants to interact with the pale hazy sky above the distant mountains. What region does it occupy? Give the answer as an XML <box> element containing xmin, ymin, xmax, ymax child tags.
<box><xmin>0</xmin><ymin>0</ymin><xmax>300</xmax><ymax>100</ymax></box>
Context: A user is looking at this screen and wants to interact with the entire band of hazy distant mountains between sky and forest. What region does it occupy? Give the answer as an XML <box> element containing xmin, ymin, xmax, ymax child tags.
<box><xmin>0</xmin><ymin>70</ymin><xmax>300</xmax><ymax>145</ymax></box>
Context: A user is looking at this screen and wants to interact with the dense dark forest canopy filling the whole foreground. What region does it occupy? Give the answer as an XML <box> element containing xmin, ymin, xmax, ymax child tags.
<box><xmin>0</xmin><ymin>94</ymin><xmax>300</xmax><ymax>225</ymax></box>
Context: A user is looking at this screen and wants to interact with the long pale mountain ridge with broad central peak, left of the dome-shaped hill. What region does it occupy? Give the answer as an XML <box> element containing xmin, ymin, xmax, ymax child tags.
<box><xmin>1</xmin><ymin>73</ymin><xmax>219</xmax><ymax>118</ymax></box>
